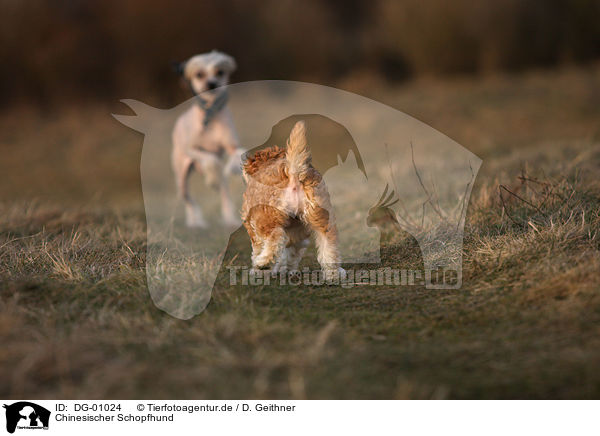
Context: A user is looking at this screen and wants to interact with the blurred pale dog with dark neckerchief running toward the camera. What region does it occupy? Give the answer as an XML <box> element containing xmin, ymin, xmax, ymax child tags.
<box><xmin>172</xmin><ymin>51</ymin><xmax>244</xmax><ymax>228</ymax></box>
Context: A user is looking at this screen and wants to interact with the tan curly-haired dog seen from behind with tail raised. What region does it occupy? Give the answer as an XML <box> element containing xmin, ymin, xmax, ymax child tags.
<box><xmin>242</xmin><ymin>121</ymin><xmax>345</xmax><ymax>278</ymax></box>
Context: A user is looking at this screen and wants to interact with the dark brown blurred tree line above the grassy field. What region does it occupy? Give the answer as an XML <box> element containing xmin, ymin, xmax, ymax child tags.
<box><xmin>0</xmin><ymin>0</ymin><xmax>600</xmax><ymax>105</ymax></box>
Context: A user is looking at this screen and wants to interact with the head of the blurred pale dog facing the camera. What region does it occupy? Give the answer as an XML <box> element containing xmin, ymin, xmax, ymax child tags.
<box><xmin>181</xmin><ymin>50</ymin><xmax>236</xmax><ymax>98</ymax></box>
